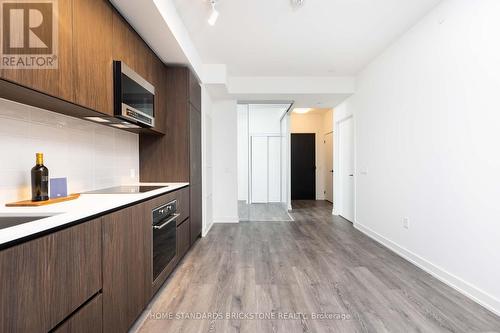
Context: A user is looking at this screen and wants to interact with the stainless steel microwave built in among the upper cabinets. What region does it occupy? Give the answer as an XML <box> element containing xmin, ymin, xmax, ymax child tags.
<box><xmin>113</xmin><ymin>61</ymin><xmax>155</xmax><ymax>127</ymax></box>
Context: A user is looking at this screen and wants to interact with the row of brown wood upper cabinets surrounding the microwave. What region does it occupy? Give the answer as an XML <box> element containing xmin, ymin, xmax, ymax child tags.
<box><xmin>0</xmin><ymin>0</ymin><xmax>167</xmax><ymax>134</ymax></box>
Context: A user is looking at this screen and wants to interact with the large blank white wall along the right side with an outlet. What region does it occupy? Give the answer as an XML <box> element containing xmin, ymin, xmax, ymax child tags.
<box><xmin>342</xmin><ymin>0</ymin><xmax>500</xmax><ymax>314</ymax></box>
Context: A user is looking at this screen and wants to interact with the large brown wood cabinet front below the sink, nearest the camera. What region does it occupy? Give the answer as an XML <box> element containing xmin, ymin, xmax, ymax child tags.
<box><xmin>0</xmin><ymin>219</ymin><xmax>102</xmax><ymax>333</ymax></box>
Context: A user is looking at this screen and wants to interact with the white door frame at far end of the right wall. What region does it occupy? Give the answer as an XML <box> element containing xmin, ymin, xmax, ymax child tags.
<box><xmin>332</xmin><ymin>113</ymin><xmax>358</xmax><ymax>224</ymax></box>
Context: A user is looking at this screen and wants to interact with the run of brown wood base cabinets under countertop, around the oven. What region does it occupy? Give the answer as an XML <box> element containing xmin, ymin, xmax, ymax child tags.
<box><xmin>0</xmin><ymin>187</ymin><xmax>192</xmax><ymax>333</ymax></box>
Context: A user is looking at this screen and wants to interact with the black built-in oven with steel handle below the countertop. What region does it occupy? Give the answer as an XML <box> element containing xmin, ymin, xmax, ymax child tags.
<box><xmin>153</xmin><ymin>200</ymin><xmax>180</xmax><ymax>281</ymax></box>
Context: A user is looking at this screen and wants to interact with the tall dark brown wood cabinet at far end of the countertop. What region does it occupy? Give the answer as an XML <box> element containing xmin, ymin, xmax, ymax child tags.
<box><xmin>140</xmin><ymin>67</ymin><xmax>202</xmax><ymax>242</ymax></box>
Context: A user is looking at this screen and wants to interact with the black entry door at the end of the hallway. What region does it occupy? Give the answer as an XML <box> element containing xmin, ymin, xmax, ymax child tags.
<box><xmin>290</xmin><ymin>133</ymin><xmax>316</xmax><ymax>200</ymax></box>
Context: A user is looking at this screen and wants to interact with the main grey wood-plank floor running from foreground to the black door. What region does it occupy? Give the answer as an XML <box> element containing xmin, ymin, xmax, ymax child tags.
<box><xmin>134</xmin><ymin>202</ymin><xmax>500</xmax><ymax>333</ymax></box>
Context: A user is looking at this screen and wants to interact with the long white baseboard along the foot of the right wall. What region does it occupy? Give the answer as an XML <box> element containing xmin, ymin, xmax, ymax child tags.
<box><xmin>354</xmin><ymin>223</ymin><xmax>500</xmax><ymax>316</ymax></box>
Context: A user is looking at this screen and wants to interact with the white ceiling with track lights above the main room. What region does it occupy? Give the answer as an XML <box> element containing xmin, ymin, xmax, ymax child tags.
<box><xmin>174</xmin><ymin>0</ymin><xmax>441</xmax><ymax>76</ymax></box>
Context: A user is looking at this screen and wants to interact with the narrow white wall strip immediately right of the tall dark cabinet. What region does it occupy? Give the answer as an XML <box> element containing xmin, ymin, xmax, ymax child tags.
<box><xmin>201</xmin><ymin>86</ymin><xmax>214</xmax><ymax>236</ymax></box>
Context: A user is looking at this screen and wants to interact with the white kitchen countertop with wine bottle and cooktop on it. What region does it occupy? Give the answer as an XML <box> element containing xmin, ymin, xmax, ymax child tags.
<box><xmin>0</xmin><ymin>183</ymin><xmax>189</xmax><ymax>247</ymax></box>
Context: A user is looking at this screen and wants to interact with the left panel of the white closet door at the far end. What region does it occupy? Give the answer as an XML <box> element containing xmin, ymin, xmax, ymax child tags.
<box><xmin>251</xmin><ymin>136</ymin><xmax>268</xmax><ymax>203</ymax></box>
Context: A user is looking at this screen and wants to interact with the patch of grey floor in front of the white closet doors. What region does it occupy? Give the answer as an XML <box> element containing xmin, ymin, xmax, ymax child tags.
<box><xmin>238</xmin><ymin>201</ymin><xmax>293</xmax><ymax>222</ymax></box>
